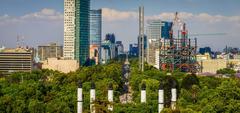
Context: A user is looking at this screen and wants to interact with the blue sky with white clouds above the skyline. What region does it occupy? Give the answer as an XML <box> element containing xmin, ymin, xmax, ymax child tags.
<box><xmin>0</xmin><ymin>0</ymin><xmax>240</xmax><ymax>50</ymax></box>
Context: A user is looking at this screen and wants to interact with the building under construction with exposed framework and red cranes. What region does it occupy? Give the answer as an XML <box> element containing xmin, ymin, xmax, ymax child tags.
<box><xmin>159</xmin><ymin>13</ymin><xmax>200</xmax><ymax>73</ymax></box>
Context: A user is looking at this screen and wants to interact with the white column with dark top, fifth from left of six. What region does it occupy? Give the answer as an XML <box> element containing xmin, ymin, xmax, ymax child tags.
<box><xmin>158</xmin><ymin>83</ymin><xmax>164</xmax><ymax>113</ymax></box>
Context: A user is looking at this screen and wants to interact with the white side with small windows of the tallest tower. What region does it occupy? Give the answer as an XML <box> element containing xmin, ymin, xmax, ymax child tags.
<box><xmin>63</xmin><ymin>0</ymin><xmax>75</xmax><ymax>59</ymax></box>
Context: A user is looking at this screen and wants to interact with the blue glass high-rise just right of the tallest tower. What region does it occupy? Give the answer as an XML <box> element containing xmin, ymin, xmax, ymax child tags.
<box><xmin>90</xmin><ymin>9</ymin><xmax>102</xmax><ymax>64</ymax></box>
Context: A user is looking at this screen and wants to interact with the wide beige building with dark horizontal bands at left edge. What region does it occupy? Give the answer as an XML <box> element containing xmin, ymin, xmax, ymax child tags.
<box><xmin>0</xmin><ymin>48</ymin><xmax>33</xmax><ymax>75</ymax></box>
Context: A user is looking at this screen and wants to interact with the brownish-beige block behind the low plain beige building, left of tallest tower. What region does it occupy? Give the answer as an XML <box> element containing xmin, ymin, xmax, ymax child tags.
<box><xmin>38</xmin><ymin>43</ymin><xmax>63</xmax><ymax>61</ymax></box>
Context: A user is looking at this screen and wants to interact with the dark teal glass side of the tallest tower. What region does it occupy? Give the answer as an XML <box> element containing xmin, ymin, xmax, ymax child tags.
<box><xmin>74</xmin><ymin>0</ymin><xmax>90</xmax><ymax>65</ymax></box>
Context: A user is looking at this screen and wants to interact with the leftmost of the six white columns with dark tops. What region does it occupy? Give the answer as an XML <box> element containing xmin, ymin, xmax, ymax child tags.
<box><xmin>77</xmin><ymin>81</ymin><xmax>83</xmax><ymax>113</ymax></box>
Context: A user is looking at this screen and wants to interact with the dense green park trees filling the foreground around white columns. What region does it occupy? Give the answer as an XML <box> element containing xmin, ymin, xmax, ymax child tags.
<box><xmin>0</xmin><ymin>58</ymin><xmax>240</xmax><ymax>113</ymax></box>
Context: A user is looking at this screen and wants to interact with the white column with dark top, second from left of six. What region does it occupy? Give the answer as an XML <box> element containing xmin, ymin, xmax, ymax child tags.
<box><xmin>90</xmin><ymin>82</ymin><xmax>96</xmax><ymax>113</ymax></box>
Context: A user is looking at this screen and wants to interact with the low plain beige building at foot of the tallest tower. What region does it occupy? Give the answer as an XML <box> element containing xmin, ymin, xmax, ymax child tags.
<box><xmin>42</xmin><ymin>58</ymin><xmax>79</xmax><ymax>73</ymax></box>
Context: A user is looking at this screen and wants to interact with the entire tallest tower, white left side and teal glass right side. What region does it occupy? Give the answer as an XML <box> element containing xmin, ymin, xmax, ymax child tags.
<box><xmin>63</xmin><ymin>0</ymin><xmax>90</xmax><ymax>65</ymax></box>
